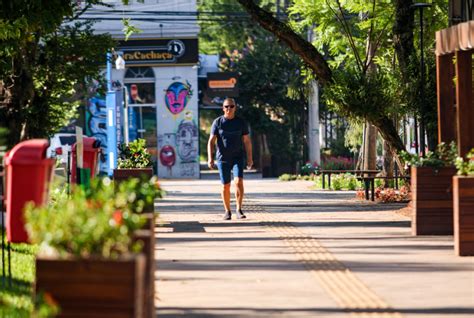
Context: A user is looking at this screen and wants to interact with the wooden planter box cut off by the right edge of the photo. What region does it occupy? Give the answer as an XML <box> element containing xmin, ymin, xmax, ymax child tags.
<box><xmin>453</xmin><ymin>176</ymin><xmax>474</xmax><ymax>256</ymax></box>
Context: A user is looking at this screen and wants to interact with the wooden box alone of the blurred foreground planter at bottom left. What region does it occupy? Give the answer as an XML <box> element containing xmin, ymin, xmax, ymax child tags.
<box><xmin>36</xmin><ymin>254</ymin><xmax>145</xmax><ymax>318</ymax></box>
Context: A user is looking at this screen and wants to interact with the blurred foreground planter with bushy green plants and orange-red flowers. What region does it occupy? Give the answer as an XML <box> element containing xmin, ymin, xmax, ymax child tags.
<box><xmin>25</xmin><ymin>178</ymin><xmax>145</xmax><ymax>317</ymax></box>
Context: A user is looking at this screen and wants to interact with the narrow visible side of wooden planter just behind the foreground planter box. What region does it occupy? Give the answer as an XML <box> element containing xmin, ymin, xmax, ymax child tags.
<box><xmin>134</xmin><ymin>229</ymin><xmax>156</xmax><ymax>318</ymax></box>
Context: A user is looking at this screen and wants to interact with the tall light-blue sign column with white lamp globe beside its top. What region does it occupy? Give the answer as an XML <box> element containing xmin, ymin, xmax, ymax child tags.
<box><xmin>105</xmin><ymin>52</ymin><xmax>125</xmax><ymax>177</ymax></box>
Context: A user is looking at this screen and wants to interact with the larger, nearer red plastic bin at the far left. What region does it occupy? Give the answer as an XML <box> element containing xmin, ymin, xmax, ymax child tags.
<box><xmin>4</xmin><ymin>139</ymin><xmax>54</xmax><ymax>243</ymax></box>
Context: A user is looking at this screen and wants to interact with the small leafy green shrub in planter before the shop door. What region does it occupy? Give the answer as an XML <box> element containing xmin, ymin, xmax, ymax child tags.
<box><xmin>114</xmin><ymin>139</ymin><xmax>153</xmax><ymax>181</ymax></box>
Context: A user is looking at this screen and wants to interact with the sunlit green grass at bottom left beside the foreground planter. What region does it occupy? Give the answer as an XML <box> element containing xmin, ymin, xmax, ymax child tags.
<box><xmin>0</xmin><ymin>237</ymin><xmax>38</xmax><ymax>317</ymax></box>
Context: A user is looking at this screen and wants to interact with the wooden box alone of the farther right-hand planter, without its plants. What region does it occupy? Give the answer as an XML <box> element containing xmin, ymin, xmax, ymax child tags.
<box><xmin>411</xmin><ymin>167</ymin><xmax>456</xmax><ymax>235</ymax></box>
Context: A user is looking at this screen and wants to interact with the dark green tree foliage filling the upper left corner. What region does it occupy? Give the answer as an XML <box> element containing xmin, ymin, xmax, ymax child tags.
<box><xmin>0</xmin><ymin>0</ymin><xmax>113</xmax><ymax>147</ymax></box>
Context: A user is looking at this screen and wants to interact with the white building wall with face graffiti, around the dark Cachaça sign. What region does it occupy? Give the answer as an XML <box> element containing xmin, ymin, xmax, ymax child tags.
<box><xmin>83</xmin><ymin>0</ymin><xmax>199</xmax><ymax>178</ymax></box>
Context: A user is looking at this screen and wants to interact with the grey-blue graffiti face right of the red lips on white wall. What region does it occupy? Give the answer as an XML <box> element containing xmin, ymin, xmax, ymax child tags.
<box><xmin>176</xmin><ymin>119</ymin><xmax>198</xmax><ymax>162</ymax></box>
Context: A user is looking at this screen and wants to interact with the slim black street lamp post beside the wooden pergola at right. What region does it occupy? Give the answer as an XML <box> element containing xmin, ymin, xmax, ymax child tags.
<box><xmin>411</xmin><ymin>3</ymin><xmax>431</xmax><ymax>157</ymax></box>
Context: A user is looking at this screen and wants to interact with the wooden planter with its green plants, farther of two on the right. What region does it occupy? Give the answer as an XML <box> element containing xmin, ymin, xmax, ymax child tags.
<box><xmin>401</xmin><ymin>143</ymin><xmax>457</xmax><ymax>235</ymax></box>
